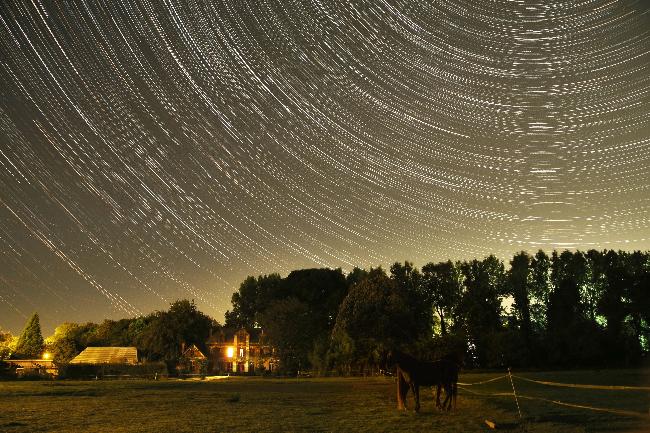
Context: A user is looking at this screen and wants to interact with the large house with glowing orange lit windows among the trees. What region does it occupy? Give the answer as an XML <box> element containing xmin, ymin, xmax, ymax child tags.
<box><xmin>206</xmin><ymin>328</ymin><xmax>278</xmax><ymax>374</ymax></box>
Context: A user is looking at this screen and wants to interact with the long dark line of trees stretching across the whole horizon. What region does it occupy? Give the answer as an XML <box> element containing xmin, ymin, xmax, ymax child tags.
<box><xmin>0</xmin><ymin>250</ymin><xmax>650</xmax><ymax>374</ymax></box>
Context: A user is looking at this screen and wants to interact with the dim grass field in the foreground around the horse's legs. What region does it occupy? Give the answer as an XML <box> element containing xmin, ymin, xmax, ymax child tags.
<box><xmin>0</xmin><ymin>370</ymin><xmax>650</xmax><ymax>433</ymax></box>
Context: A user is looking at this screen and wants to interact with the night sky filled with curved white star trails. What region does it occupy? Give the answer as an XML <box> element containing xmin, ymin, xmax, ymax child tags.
<box><xmin>0</xmin><ymin>0</ymin><xmax>650</xmax><ymax>335</ymax></box>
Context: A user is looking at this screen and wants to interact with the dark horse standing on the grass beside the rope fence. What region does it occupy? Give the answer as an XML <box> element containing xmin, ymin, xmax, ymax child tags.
<box><xmin>387</xmin><ymin>350</ymin><xmax>460</xmax><ymax>412</ymax></box>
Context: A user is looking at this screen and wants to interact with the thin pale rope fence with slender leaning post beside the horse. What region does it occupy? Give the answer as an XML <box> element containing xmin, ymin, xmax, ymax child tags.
<box><xmin>458</xmin><ymin>371</ymin><xmax>650</xmax><ymax>419</ymax></box>
